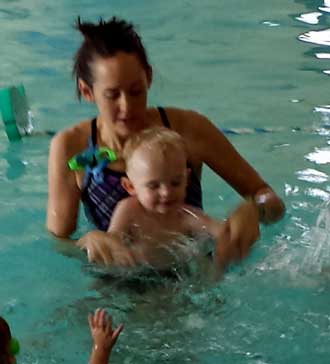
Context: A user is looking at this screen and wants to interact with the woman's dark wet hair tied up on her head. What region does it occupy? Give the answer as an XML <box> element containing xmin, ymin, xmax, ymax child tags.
<box><xmin>72</xmin><ymin>16</ymin><xmax>152</xmax><ymax>99</ymax></box>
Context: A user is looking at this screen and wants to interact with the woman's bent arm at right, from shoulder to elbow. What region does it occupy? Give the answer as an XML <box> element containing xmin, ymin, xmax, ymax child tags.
<box><xmin>168</xmin><ymin>109</ymin><xmax>285</xmax><ymax>223</ymax></box>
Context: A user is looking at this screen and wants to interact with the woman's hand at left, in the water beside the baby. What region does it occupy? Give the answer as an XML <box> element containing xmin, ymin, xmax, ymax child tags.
<box><xmin>77</xmin><ymin>230</ymin><xmax>137</xmax><ymax>267</ymax></box>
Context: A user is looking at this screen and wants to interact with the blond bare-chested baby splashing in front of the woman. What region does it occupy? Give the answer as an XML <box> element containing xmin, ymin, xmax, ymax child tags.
<box><xmin>78</xmin><ymin>127</ymin><xmax>258</xmax><ymax>270</ymax></box>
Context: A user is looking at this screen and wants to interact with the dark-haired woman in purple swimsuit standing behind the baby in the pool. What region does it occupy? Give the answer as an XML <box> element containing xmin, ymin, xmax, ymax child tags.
<box><xmin>47</xmin><ymin>17</ymin><xmax>284</xmax><ymax>264</ymax></box>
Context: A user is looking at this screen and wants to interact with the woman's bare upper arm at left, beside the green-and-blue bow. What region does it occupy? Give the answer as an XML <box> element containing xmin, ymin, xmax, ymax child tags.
<box><xmin>46</xmin><ymin>131</ymin><xmax>80</xmax><ymax>238</ymax></box>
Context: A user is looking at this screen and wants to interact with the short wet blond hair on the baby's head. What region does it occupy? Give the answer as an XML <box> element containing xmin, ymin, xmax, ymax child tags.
<box><xmin>123</xmin><ymin>126</ymin><xmax>187</xmax><ymax>166</ymax></box>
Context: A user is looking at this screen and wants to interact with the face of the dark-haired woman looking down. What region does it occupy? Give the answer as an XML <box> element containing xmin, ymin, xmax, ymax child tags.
<box><xmin>87</xmin><ymin>52</ymin><xmax>149</xmax><ymax>139</ymax></box>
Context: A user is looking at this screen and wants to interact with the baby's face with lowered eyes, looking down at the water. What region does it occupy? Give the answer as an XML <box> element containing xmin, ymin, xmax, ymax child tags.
<box><xmin>127</xmin><ymin>145</ymin><xmax>187</xmax><ymax>214</ymax></box>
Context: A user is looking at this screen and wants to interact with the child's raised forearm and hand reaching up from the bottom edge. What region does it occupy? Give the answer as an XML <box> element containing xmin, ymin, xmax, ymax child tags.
<box><xmin>88</xmin><ymin>308</ymin><xmax>124</xmax><ymax>364</ymax></box>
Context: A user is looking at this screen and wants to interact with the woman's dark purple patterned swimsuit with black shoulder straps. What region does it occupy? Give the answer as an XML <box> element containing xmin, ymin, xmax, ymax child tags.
<box><xmin>81</xmin><ymin>107</ymin><xmax>202</xmax><ymax>231</ymax></box>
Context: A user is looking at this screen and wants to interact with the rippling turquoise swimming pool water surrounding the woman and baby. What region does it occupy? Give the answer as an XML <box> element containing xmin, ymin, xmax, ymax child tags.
<box><xmin>0</xmin><ymin>0</ymin><xmax>330</xmax><ymax>364</ymax></box>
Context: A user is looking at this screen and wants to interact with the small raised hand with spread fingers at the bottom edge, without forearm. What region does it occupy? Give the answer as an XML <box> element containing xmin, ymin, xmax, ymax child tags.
<box><xmin>88</xmin><ymin>308</ymin><xmax>124</xmax><ymax>353</ymax></box>
